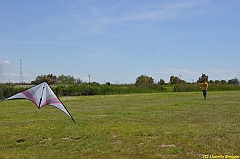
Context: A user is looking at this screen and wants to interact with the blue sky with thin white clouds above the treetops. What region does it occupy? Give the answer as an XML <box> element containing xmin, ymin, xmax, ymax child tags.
<box><xmin>0</xmin><ymin>0</ymin><xmax>240</xmax><ymax>84</ymax></box>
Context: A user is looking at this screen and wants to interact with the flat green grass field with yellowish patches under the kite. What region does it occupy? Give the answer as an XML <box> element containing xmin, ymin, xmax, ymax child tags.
<box><xmin>0</xmin><ymin>91</ymin><xmax>240</xmax><ymax>159</ymax></box>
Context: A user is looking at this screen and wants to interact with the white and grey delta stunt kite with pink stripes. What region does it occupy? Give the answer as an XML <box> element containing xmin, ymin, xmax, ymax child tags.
<box><xmin>6</xmin><ymin>82</ymin><xmax>75</xmax><ymax>122</ymax></box>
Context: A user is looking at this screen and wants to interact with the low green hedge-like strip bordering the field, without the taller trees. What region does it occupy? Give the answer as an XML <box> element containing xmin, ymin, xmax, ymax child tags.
<box><xmin>0</xmin><ymin>83</ymin><xmax>240</xmax><ymax>100</ymax></box>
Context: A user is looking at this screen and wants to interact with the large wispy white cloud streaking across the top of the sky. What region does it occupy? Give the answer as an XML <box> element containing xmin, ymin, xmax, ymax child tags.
<box><xmin>42</xmin><ymin>0</ymin><xmax>210</xmax><ymax>37</ymax></box>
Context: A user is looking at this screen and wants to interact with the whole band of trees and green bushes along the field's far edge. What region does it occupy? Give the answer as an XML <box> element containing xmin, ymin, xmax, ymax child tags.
<box><xmin>0</xmin><ymin>74</ymin><xmax>240</xmax><ymax>100</ymax></box>
